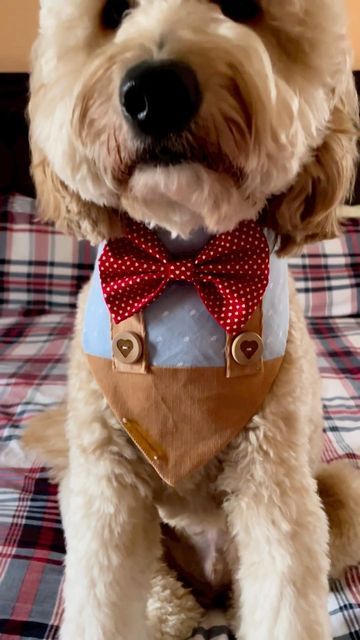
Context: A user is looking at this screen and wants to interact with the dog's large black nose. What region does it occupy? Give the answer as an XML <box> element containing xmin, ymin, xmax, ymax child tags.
<box><xmin>120</xmin><ymin>60</ymin><xmax>201</xmax><ymax>137</ymax></box>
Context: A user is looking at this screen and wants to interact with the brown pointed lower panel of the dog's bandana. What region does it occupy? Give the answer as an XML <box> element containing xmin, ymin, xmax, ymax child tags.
<box><xmin>87</xmin><ymin>355</ymin><xmax>282</xmax><ymax>485</ymax></box>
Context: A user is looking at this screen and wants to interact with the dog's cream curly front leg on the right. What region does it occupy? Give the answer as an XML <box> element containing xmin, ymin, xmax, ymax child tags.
<box><xmin>223</xmin><ymin>428</ymin><xmax>331</xmax><ymax>640</ymax></box>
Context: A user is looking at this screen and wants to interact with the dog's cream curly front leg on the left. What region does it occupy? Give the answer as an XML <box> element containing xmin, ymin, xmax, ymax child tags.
<box><xmin>61</xmin><ymin>444</ymin><xmax>160</xmax><ymax>640</ymax></box>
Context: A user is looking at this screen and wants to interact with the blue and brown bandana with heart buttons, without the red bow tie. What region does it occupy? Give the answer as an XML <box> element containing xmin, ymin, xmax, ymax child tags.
<box><xmin>83</xmin><ymin>231</ymin><xmax>288</xmax><ymax>484</ymax></box>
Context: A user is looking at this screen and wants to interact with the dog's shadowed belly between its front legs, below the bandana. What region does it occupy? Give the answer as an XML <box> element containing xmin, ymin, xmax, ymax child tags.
<box><xmin>157</xmin><ymin>470</ymin><xmax>238</xmax><ymax>608</ymax></box>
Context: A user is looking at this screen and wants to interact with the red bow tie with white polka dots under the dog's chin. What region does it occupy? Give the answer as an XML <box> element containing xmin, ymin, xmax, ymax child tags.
<box><xmin>99</xmin><ymin>220</ymin><xmax>269</xmax><ymax>335</ymax></box>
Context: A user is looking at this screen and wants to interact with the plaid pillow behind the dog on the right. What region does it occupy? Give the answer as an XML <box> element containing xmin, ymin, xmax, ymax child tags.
<box><xmin>289</xmin><ymin>218</ymin><xmax>360</xmax><ymax>318</ymax></box>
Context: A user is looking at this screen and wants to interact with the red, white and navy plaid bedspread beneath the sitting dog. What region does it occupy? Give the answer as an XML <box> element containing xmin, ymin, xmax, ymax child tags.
<box><xmin>0</xmin><ymin>199</ymin><xmax>360</xmax><ymax>640</ymax></box>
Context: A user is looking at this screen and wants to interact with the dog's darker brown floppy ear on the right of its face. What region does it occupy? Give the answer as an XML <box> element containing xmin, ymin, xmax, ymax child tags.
<box><xmin>263</xmin><ymin>77</ymin><xmax>359</xmax><ymax>255</ymax></box>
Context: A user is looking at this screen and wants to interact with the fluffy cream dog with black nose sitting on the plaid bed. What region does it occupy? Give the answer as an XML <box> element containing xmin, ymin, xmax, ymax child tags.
<box><xmin>24</xmin><ymin>0</ymin><xmax>360</xmax><ymax>640</ymax></box>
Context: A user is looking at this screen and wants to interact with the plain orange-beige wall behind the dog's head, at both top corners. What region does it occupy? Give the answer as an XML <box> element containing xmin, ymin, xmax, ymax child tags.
<box><xmin>0</xmin><ymin>0</ymin><xmax>360</xmax><ymax>72</ymax></box>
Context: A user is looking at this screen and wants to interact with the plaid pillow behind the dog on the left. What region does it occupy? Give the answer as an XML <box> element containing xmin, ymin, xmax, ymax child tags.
<box><xmin>0</xmin><ymin>195</ymin><xmax>96</xmax><ymax>314</ymax></box>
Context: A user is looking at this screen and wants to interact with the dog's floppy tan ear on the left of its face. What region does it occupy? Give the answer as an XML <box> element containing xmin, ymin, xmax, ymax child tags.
<box><xmin>32</xmin><ymin>144</ymin><xmax>121</xmax><ymax>244</ymax></box>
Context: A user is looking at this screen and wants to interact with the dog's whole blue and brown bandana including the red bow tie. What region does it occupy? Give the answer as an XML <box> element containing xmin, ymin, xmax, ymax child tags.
<box><xmin>83</xmin><ymin>222</ymin><xmax>289</xmax><ymax>485</ymax></box>
